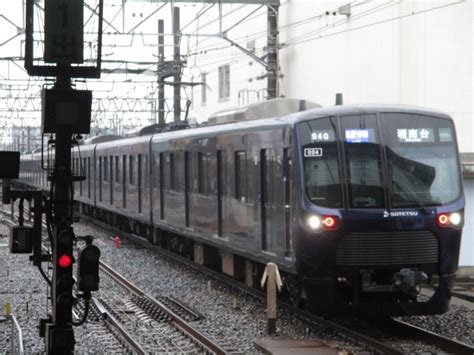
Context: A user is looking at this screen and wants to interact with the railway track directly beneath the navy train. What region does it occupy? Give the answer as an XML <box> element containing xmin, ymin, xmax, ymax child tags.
<box><xmin>76</xmin><ymin>215</ymin><xmax>474</xmax><ymax>354</ymax></box>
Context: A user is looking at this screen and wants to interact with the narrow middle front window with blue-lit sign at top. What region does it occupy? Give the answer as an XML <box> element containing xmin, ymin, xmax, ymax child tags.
<box><xmin>340</xmin><ymin>114</ymin><xmax>384</xmax><ymax>208</ymax></box>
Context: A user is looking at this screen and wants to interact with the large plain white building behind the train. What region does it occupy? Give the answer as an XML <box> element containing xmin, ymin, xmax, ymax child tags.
<box><xmin>182</xmin><ymin>0</ymin><xmax>474</xmax><ymax>265</ymax></box>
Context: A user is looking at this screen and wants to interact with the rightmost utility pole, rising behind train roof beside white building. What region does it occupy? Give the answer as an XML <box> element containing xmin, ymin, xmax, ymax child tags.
<box><xmin>267</xmin><ymin>5</ymin><xmax>279</xmax><ymax>99</ymax></box>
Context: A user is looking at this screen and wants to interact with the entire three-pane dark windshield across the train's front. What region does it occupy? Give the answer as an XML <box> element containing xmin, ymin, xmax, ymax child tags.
<box><xmin>298</xmin><ymin>113</ymin><xmax>461</xmax><ymax>208</ymax></box>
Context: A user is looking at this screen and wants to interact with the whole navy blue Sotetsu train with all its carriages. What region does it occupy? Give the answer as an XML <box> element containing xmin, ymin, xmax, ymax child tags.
<box><xmin>21</xmin><ymin>101</ymin><xmax>465</xmax><ymax>316</ymax></box>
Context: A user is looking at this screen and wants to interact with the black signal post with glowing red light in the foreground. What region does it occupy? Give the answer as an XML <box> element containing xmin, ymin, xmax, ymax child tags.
<box><xmin>25</xmin><ymin>0</ymin><xmax>103</xmax><ymax>354</ymax></box>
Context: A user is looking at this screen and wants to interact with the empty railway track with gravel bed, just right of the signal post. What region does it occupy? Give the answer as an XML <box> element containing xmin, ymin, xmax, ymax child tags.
<box><xmin>0</xmin><ymin>204</ymin><xmax>226</xmax><ymax>355</ymax></box>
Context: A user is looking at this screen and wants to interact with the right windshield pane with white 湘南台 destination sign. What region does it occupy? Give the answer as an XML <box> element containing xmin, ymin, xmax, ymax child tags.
<box><xmin>381</xmin><ymin>113</ymin><xmax>461</xmax><ymax>207</ymax></box>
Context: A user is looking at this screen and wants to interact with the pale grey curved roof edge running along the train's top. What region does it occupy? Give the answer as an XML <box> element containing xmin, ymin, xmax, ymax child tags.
<box><xmin>81</xmin><ymin>104</ymin><xmax>451</xmax><ymax>149</ymax></box>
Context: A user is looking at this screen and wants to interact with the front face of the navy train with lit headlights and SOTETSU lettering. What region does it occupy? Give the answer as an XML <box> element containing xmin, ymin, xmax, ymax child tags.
<box><xmin>295</xmin><ymin>110</ymin><xmax>464</xmax><ymax>316</ymax></box>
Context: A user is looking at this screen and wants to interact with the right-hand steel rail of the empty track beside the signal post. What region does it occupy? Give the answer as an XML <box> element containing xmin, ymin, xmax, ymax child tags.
<box><xmin>100</xmin><ymin>261</ymin><xmax>227</xmax><ymax>355</ymax></box>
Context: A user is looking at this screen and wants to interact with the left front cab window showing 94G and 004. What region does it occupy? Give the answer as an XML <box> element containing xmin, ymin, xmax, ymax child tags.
<box><xmin>298</xmin><ymin>117</ymin><xmax>342</xmax><ymax>208</ymax></box>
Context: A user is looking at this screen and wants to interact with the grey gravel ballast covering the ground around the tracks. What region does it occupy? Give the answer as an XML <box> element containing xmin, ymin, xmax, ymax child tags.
<box><xmin>0</xmin><ymin>222</ymin><xmax>474</xmax><ymax>353</ymax></box>
